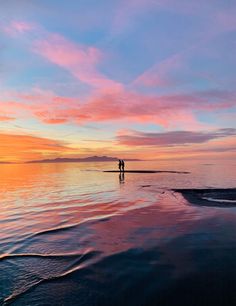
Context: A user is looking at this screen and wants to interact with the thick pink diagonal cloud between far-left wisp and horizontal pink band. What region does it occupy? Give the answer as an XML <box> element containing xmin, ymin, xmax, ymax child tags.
<box><xmin>33</xmin><ymin>34</ymin><xmax>122</xmax><ymax>91</ymax></box>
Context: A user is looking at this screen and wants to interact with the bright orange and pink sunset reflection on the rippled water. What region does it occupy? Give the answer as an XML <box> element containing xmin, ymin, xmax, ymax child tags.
<box><xmin>0</xmin><ymin>162</ymin><xmax>235</xmax><ymax>252</ymax></box>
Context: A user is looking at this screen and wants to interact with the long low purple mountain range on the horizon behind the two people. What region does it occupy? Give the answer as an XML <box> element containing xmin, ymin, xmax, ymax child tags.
<box><xmin>27</xmin><ymin>156</ymin><xmax>139</xmax><ymax>164</ymax></box>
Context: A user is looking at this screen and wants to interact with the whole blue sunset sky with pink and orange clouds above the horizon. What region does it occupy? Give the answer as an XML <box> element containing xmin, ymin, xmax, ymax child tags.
<box><xmin>0</xmin><ymin>0</ymin><xmax>236</xmax><ymax>162</ymax></box>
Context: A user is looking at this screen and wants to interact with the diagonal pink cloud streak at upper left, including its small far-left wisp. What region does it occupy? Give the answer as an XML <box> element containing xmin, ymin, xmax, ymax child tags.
<box><xmin>2</xmin><ymin>21</ymin><xmax>123</xmax><ymax>92</ymax></box>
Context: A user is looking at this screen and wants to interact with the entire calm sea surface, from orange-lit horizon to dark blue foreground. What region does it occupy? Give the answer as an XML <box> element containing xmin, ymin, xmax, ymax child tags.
<box><xmin>0</xmin><ymin>161</ymin><xmax>236</xmax><ymax>306</ymax></box>
